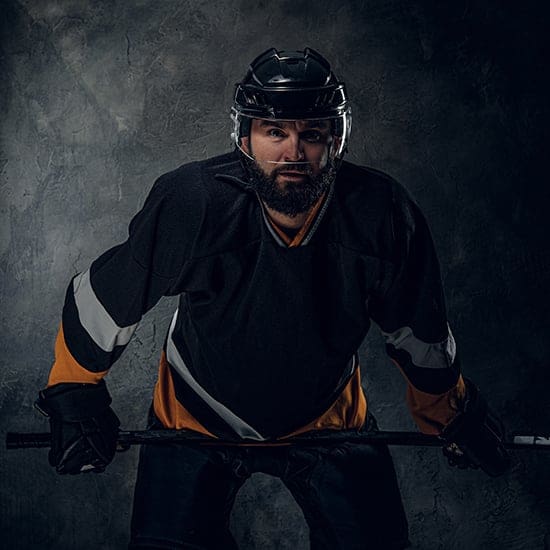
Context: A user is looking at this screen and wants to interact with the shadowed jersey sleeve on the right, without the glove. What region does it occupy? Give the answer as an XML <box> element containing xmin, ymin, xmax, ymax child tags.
<box><xmin>370</xmin><ymin>184</ymin><xmax>465</xmax><ymax>434</ymax></box>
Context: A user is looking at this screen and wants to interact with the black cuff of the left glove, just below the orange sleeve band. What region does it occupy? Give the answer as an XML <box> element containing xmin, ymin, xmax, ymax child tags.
<box><xmin>35</xmin><ymin>380</ymin><xmax>112</xmax><ymax>422</ymax></box>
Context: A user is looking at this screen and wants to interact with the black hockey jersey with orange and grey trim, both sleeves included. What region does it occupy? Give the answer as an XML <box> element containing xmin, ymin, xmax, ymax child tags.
<box><xmin>48</xmin><ymin>153</ymin><xmax>464</xmax><ymax>440</ymax></box>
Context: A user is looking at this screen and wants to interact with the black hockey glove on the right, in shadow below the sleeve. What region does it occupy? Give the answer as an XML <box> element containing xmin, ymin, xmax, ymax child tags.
<box><xmin>440</xmin><ymin>378</ymin><xmax>510</xmax><ymax>476</ymax></box>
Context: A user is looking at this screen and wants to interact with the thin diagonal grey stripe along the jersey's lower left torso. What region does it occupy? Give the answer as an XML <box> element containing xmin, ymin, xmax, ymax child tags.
<box><xmin>166</xmin><ymin>310</ymin><xmax>266</xmax><ymax>441</ymax></box>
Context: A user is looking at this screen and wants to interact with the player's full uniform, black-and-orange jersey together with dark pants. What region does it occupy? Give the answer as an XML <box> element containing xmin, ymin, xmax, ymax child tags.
<box><xmin>48</xmin><ymin>153</ymin><xmax>470</xmax><ymax>550</ymax></box>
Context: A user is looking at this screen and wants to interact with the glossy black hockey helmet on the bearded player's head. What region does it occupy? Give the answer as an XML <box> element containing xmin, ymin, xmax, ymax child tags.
<box><xmin>231</xmin><ymin>48</ymin><xmax>351</xmax><ymax>159</ymax></box>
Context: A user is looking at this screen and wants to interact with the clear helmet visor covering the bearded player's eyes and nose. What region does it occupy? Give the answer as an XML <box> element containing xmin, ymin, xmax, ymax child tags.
<box><xmin>231</xmin><ymin>109</ymin><xmax>351</xmax><ymax>169</ymax></box>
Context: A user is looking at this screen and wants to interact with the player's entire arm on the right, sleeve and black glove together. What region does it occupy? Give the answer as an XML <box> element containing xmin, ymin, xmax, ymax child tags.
<box><xmin>370</xmin><ymin>184</ymin><xmax>507</xmax><ymax>473</ymax></box>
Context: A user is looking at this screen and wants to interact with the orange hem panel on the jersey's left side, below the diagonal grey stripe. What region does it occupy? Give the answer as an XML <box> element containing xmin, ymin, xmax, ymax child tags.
<box><xmin>153</xmin><ymin>351</ymin><xmax>216</xmax><ymax>437</ymax></box>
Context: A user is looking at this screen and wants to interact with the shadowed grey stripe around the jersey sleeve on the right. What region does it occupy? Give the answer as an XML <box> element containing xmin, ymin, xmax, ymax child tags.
<box><xmin>382</xmin><ymin>325</ymin><xmax>456</xmax><ymax>369</ymax></box>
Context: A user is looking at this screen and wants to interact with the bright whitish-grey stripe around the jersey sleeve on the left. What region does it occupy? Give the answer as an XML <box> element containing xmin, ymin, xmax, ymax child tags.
<box><xmin>73</xmin><ymin>270</ymin><xmax>138</xmax><ymax>352</ymax></box>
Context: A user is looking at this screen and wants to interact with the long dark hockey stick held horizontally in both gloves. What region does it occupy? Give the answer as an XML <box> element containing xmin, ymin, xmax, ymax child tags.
<box><xmin>6</xmin><ymin>430</ymin><xmax>550</xmax><ymax>451</ymax></box>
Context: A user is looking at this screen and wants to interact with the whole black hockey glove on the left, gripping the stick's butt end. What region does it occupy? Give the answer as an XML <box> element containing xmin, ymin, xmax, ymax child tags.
<box><xmin>35</xmin><ymin>380</ymin><xmax>120</xmax><ymax>474</ymax></box>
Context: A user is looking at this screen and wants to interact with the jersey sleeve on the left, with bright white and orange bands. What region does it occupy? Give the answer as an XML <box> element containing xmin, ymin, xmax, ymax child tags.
<box><xmin>48</xmin><ymin>177</ymin><xmax>192</xmax><ymax>386</ymax></box>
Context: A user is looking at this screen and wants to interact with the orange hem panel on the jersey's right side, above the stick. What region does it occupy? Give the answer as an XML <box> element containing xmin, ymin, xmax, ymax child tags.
<box><xmin>285</xmin><ymin>367</ymin><xmax>367</xmax><ymax>437</ymax></box>
